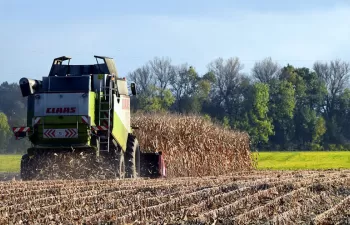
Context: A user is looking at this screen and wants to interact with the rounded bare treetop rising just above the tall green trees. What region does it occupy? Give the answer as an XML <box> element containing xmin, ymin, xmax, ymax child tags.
<box><xmin>252</xmin><ymin>57</ymin><xmax>280</xmax><ymax>84</ymax></box>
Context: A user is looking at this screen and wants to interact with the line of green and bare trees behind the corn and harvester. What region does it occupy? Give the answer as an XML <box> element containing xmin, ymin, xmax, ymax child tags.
<box><xmin>0</xmin><ymin>57</ymin><xmax>350</xmax><ymax>153</ymax></box>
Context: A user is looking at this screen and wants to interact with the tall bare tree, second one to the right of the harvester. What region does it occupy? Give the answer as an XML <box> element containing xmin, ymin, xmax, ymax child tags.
<box><xmin>149</xmin><ymin>57</ymin><xmax>174</xmax><ymax>97</ymax></box>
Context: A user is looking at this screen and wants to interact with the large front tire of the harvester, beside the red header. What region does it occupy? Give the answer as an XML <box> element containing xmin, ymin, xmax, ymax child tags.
<box><xmin>125</xmin><ymin>135</ymin><xmax>140</xmax><ymax>178</ymax></box>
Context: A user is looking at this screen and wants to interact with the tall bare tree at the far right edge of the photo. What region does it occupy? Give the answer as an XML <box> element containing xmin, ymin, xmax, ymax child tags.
<box><xmin>313</xmin><ymin>59</ymin><xmax>350</xmax><ymax>118</ymax></box>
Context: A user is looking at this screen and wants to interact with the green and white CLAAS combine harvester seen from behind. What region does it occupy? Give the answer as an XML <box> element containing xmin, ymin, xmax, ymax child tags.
<box><xmin>13</xmin><ymin>56</ymin><xmax>165</xmax><ymax>180</ymax></box>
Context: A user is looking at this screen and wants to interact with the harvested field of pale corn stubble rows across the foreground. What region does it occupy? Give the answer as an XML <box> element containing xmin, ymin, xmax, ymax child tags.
<box><xmin>0</xmin><ymin>170</ymin><xmax>350</xmax><ymax>224</ymax></box>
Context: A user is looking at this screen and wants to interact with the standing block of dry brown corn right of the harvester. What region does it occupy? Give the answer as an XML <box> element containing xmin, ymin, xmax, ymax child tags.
<box><xmin>132</xmin><ymin>114</ymin><xmax>256</xmax><ymax>177</ymax></box>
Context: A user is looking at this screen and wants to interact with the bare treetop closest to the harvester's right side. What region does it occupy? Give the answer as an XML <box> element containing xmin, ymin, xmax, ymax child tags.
<box><xmin>129</xmin><ymin>65</ymin><xmax>155</xmax><ymax>94</ymax></box>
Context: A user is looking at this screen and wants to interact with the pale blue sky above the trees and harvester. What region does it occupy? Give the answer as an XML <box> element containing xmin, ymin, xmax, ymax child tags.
<box><xmin>0</xmin><ymin>0</ymin><xmax>350</xmax><ymax>82</ymax></box>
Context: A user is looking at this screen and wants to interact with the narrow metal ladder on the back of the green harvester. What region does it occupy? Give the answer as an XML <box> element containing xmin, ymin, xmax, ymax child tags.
<box><xmin>98</xmin><ymin>75</ymin><xmax>113</xmax><ymax>152</ymax></box>
